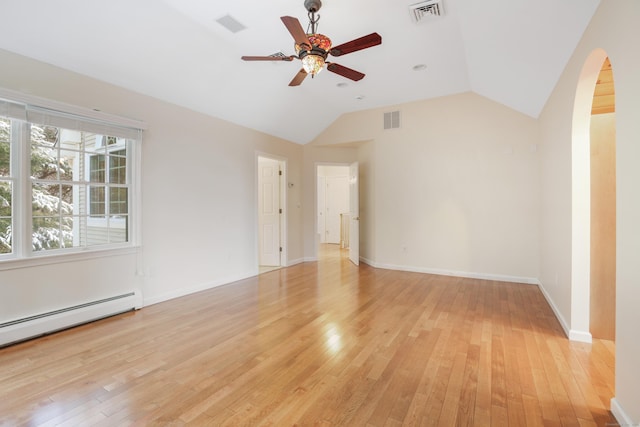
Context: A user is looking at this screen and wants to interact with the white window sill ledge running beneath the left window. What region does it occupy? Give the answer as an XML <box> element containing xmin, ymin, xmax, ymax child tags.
<box><xmin>0</xmin><ymin>246</ymin><xmax>140</xmax><ymax>271</ymax></box>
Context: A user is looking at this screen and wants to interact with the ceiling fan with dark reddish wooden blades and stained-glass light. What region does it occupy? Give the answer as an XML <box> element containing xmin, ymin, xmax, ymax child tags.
<box><xmin>242</xmin><ymin>0</ymin><xmax>382</xmax><ymax>86</ymax></box>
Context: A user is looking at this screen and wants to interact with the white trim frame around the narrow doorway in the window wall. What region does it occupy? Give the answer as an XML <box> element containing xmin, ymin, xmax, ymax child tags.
<box><xmin>253</xmin><ymin>151</ymin><xmax>288</xmax><ymax>268</ymax></box>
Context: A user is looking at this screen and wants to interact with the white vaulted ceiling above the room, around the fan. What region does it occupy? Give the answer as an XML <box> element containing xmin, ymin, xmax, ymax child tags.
<box><xmin>0</xmin><ymin>0</ymin><xmax>600</xmax><ymax>144</ymax></box>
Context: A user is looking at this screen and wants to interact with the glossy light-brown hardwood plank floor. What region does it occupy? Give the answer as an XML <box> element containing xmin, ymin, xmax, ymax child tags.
<box><xmin>0</xmin><ymin>248</ymin><xmax>615</xmax><ymax>426</ymax></box>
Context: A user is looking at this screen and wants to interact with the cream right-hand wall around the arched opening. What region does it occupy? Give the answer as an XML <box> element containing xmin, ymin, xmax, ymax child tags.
<box><xmin>540</xmin><ymin>0</ymin><xmax>640</xmax><ymax>424</ymax></box>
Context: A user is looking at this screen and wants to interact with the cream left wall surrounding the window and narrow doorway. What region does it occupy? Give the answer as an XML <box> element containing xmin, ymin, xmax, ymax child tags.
<box><xmin>0</xmin><ymin>50</ymin><xmax>303</xmax><ymax>321</ymax></box>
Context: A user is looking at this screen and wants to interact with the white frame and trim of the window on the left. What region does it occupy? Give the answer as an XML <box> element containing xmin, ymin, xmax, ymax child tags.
<box><xmin>0</xmin><ymin>88</ymin><xmax>146</xmax><ymax>270</ymax></box>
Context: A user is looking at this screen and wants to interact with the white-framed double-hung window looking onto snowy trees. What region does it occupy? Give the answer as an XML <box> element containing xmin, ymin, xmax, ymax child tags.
<box><xmin>0</xmin><ymin>94</ymin><xmax>142</xmax><ymax>261</ymax></box>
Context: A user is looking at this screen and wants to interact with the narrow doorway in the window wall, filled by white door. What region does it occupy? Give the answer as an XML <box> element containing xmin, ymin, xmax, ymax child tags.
<box><xmin>257</xmin><ymin>155</ymin><xmax>286</xmax><ymax>273</ymax></box>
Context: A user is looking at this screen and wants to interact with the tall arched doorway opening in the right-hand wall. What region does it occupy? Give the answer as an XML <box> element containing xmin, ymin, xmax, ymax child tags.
<box><xmin>571</xmin><ymin>49</ymin><xmax>615</xmax><ymax>342</ymax></box>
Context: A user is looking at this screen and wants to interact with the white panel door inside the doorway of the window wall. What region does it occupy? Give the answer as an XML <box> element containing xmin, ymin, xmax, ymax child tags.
<box><xmin>258</xmin><ymin>157</ymin><xmax>280</xmax><ymax>267</ymax></box>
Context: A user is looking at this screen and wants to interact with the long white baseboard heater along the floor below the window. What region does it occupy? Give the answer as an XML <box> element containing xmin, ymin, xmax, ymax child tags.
<box><xmin>0</xmin><ymin>291</ymin><xmax>142</xmax><ymax>347</ymax></box>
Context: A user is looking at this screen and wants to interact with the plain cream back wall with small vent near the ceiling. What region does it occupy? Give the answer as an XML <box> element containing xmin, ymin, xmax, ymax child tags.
<box><xmin>313</xmin><ymin>93</ymin><xmax>539</xmax><ymax>283</ymax></box>
